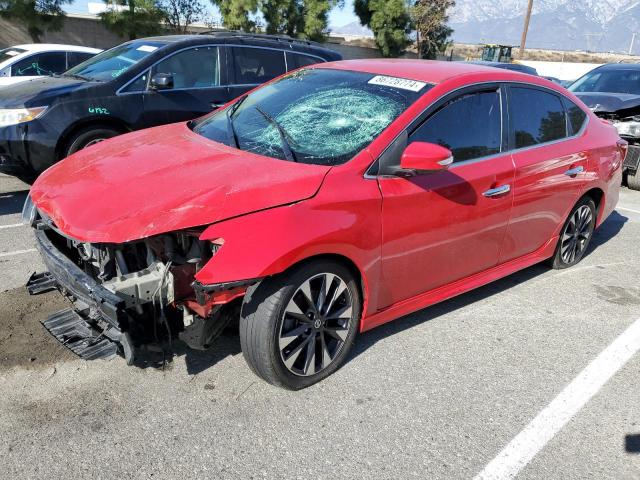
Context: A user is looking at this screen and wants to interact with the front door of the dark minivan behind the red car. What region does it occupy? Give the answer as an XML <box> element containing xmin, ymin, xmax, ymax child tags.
<box><xmin>144</xmin><ymin>45</ymin><xmax>230</xmax><ymax>126</ymax></box>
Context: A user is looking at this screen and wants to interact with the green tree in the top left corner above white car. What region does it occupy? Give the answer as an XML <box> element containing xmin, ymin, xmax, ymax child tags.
<box><xmin>0</xmin><ymin>0</ymin><xmax>73</xmax><ymax>42</ymax></box>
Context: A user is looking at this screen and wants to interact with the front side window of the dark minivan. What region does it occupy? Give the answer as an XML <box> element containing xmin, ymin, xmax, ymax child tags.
<box><xmin>151</xmin><ymin>47</ymin><xmax>220</xmax><ymax>89</ymax></box>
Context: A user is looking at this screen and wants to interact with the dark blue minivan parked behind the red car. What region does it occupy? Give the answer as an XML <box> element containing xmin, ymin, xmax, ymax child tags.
<box><xmin>0</xmin><ymin>32</ymin><xmax>341</xmax><ymax>182</ymax></box>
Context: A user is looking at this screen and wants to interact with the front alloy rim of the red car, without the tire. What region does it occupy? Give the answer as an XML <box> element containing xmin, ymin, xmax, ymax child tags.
<box><xmin>278</xmin><ymin>273</ymin><xmax>354</xmax><ymax>376</ymax></box>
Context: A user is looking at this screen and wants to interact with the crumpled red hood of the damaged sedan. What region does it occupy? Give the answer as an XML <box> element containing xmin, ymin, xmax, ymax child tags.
<box><xmin>30</xmin><ymin>123</ymin><xmax>331</xmax><ymax>243</ymax></box>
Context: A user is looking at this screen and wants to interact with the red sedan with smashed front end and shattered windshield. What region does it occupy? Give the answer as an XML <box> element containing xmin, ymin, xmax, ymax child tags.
<box><xmin>23</xmin><ymin>60</ymin><xmax>626</xmax><ymax>389</ymax></box>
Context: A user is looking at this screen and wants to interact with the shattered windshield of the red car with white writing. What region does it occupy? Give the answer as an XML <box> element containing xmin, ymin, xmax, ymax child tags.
<box><xmin>194</xmin><ymin>68</ymin><xmax>431</xmax><ymax>165</ymax></box>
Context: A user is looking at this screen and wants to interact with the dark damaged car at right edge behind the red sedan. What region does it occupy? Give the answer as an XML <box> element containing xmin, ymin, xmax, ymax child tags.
<box><xmin>568</xmin><ymin>63</ymin><xmax>640</xmax><ymax>190</ymax></box>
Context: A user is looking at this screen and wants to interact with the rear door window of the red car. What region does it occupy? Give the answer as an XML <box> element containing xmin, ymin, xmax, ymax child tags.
<box><xmin>509</xmin><ymin>87</ymin><xmax>567</xmax><ymax>148</ymax></box>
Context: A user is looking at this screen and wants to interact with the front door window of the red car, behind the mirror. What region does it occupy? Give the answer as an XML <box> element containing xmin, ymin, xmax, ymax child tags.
<box><xmin>409</xmin><ymin>90</ymin><xmax>502</xmax><ymax>162</ymax></box>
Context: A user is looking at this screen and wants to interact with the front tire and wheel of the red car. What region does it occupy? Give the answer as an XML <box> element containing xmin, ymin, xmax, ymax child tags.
<box><xmin>240</xmin><ymin>260</ymin><xmax>362</xmax><ymax>390</ymax></box>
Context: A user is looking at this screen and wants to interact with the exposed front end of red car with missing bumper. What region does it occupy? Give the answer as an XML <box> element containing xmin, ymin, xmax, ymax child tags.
<box><xmin>23</xmin><ymin>202</ymin><xmax>246</xmax><ymax>363</ymax></box>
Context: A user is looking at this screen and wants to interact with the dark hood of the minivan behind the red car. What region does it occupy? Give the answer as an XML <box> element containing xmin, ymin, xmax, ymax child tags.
<box><xmin>0</xmin><ymin>77</ymin><xmax>97</xmax><ymax>108</ymax></box>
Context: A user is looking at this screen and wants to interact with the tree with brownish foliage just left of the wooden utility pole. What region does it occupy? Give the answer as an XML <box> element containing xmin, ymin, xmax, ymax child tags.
<box><xmin>411</xmin><ymin>0</ymin><xmax>456</xmax><ymax>60</ymax></box>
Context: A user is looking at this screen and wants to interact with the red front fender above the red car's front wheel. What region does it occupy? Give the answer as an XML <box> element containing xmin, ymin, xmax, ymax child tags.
<box><xmin>195</xmin><ymin>168</ymin><xmax>382</xmax><ymax>315</ymax></box>
